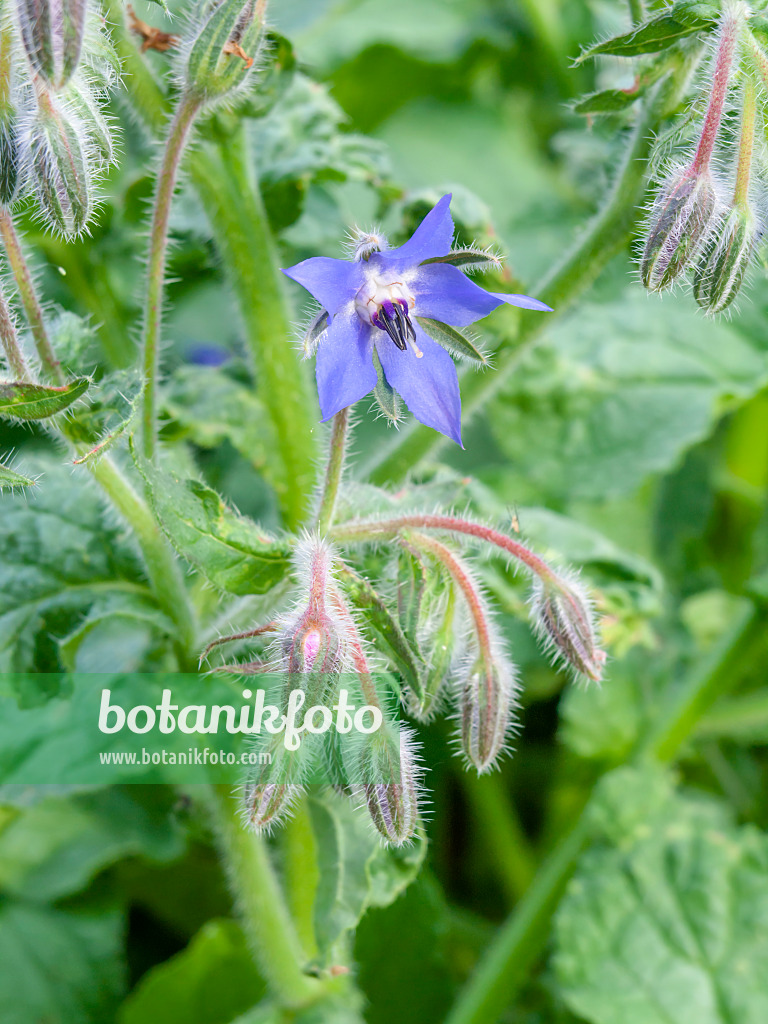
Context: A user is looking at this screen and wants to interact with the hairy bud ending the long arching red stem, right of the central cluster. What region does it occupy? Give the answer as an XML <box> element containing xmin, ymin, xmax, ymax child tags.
<box><xmin>531</xmin><ymin>575</ymin><xmax>605</xmax><ymax>681</ymax></box>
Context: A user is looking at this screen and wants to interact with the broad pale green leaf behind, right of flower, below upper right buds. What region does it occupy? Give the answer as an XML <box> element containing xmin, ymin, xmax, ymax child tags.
<box><xmin>489</xmin><ymin>289</ymin><xmax>768</xmax><ymax>502</ymax></box>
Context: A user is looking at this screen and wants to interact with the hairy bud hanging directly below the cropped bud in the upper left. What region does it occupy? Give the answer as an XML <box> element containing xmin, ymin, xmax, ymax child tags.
<box><xmin>27</xmin><ymin>93</ymin><xmax>93</xmax><ymax>237</ymax></box>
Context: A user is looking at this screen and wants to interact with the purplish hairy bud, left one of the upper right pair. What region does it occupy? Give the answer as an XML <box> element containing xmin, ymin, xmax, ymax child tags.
<box><xmin>640</xmin><ymin>168</ymin><xmax>718</xmax><ymax>292</ymax></box>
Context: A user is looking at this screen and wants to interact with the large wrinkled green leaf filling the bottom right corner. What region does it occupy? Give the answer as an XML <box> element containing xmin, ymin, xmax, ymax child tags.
<box><xmin>555</xmin><ymin>769</ymin><xmax>768</xmax><ymax>1024</ymax></box>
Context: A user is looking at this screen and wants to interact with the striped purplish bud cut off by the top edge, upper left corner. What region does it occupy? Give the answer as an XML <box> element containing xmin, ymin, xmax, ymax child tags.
<box><xmin>15</xmin><ymin>0</ymin><xmax>87</xmax><ymax>89</ymax></box>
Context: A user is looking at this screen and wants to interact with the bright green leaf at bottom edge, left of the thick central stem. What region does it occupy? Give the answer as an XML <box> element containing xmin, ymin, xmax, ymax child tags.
<box><xmin>117</xmin><ymin>919</ymin><xmax>264</xmax><ymax>1024</ymax></box>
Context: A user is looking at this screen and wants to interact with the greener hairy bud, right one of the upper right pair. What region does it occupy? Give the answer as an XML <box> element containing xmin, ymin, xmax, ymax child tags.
<box><xmin>693</xmin><ymin>206</ymin><xmax>758</xmax><ymax>313</ymax></box>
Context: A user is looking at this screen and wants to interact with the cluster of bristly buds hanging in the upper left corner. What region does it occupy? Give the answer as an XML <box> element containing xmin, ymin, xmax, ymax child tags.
<box><xmin>0</xmin><ymin>0</ymin><xmax>120</xmax><ymax>238</ymax></box>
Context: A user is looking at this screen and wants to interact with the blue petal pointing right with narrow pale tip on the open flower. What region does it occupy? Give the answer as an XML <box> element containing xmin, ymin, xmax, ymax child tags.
<box><xmin>410</xmin><ymin>263</ymin><xmax>550</xmax><ymax>327</ymax></box>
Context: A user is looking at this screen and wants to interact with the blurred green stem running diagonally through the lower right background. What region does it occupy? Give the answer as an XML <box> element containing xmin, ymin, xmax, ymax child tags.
<box><xmin>445</xmin><ymin>598</ymin><xmax>765</xmax><ymax>1024</ymax></box>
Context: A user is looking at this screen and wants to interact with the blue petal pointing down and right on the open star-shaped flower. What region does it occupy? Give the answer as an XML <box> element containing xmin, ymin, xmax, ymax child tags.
<box><xmin>376</xmin><ymin>324</ymin><xmax>464</xmax><ymax>447</ymax></box>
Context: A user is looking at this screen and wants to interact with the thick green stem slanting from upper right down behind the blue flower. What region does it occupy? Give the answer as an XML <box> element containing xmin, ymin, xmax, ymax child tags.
<box><xmin>372</xmin><ymin>83</ymin><xmax>670</xmax><ymax>484</ymax></box>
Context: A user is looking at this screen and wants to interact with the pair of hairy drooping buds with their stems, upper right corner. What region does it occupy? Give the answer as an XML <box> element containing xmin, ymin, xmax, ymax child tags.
<box><xmin>640</xmin><ymin>3</ymin><xmax>768</xmax><ymax>313</ymax></box>
